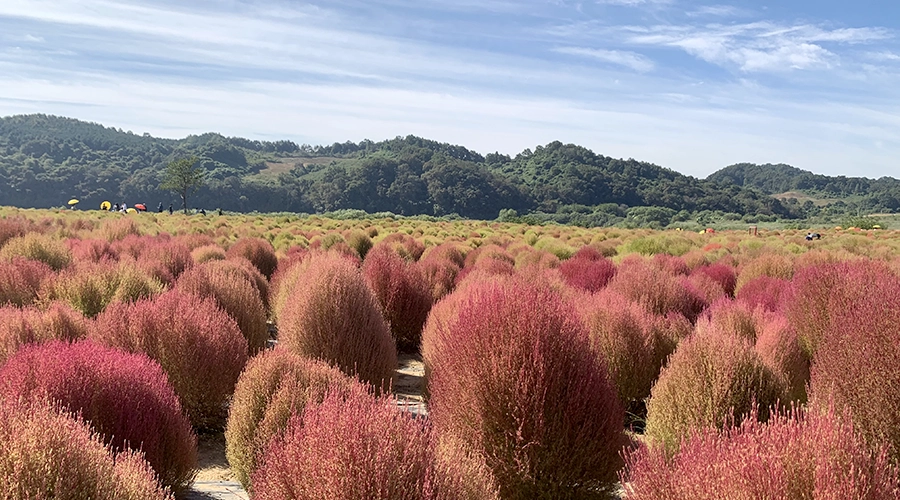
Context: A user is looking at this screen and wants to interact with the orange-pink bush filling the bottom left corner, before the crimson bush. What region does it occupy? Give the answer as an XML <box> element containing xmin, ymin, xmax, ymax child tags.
<box><xmin>0</xmin><ymin>401</ymin><xmax>173</xmax><ymax>500</ymax></box>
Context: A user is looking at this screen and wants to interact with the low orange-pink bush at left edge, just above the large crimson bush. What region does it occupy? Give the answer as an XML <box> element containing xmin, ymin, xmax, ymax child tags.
<box><xmin>0</xmin><ymin>302</ymin><xmax>87</xmax><ymax>365</ymax></box>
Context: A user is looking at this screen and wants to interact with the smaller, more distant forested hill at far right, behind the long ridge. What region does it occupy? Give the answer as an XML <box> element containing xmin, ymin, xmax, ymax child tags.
<box><xmin>707</xmin><ymin>163</ymin><xmax>900</xmax><ymax>212</ymax></box>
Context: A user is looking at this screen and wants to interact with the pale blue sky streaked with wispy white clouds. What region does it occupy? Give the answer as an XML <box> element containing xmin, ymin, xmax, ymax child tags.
<box><xmin>0</xmin><ymin>0</ymin><xmax>900</xmax><ymax>177</ymax></box>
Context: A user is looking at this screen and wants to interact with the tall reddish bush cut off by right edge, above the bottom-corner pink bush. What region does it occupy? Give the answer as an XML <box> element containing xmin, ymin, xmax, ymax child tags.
<box><xmin>808</xmin><ymin>261</ymin><xmax>900</xmax><ymax>464</ymax></box>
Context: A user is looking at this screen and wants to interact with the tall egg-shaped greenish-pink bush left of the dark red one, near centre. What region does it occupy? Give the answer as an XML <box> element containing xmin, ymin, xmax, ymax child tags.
<box><xmin>278</xmin><ymin>254</ymin><xmax>397</xmax><ymax>388</ymax></box>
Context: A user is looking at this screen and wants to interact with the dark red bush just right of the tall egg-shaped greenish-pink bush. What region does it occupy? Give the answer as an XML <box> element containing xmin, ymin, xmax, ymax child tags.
<box><xmin>362</xmin><ymin>246</ymin><xmax>432</xmax><ymax>352</ymax></box>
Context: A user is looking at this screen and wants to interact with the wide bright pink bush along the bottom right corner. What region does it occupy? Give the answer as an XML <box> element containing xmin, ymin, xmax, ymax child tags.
<box><xmin>622</xmin><ymin>409</ymin><xmax>900</xmax><ymax>500</ymax></box>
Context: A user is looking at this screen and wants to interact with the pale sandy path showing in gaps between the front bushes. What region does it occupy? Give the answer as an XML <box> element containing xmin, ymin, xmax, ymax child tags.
<box><xmin>183</xmin><ymin>354</ymin><xmax>428</xmax><ymax>500</ymax></box>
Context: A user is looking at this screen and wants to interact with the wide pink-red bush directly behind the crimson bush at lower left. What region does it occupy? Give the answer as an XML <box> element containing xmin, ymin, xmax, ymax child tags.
<box><xmin>89</xmin><ymin>290</ymin><xmax>247</xmax><ymax>429</ymax></box>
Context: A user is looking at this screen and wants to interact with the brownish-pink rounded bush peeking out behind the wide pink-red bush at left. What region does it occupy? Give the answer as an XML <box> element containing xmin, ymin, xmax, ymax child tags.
<box><xmin>175</xmin><ymin>266</ymin><xmax>269</xmax><ymax>356</ymax></box>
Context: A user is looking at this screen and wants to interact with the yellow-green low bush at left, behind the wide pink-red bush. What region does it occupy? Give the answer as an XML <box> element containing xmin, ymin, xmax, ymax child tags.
<box><xmin>41</xmin><ymin>261</ymin><xmax>163</xmax><ymax>318</ymax></box>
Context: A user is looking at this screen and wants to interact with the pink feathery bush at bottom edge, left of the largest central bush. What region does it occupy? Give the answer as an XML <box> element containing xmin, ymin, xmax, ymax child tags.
<box><xmin>253</xmin><ymin>383</ymin><xmax>496</xmax><ymax>500</ymax></box>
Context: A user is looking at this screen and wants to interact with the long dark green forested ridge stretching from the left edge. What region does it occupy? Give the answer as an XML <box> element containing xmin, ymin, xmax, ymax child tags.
<box><xmin>0</xmin><ymin>115</ymin><xmax>797</xmax><ymax>225</ymax></box>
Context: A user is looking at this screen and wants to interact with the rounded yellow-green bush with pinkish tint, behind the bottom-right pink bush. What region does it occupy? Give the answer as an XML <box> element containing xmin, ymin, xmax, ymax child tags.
<box><xmin>645</xmin><ymin>331</ymin><xmax>786</xmax><ymax>450</ymax></box>
